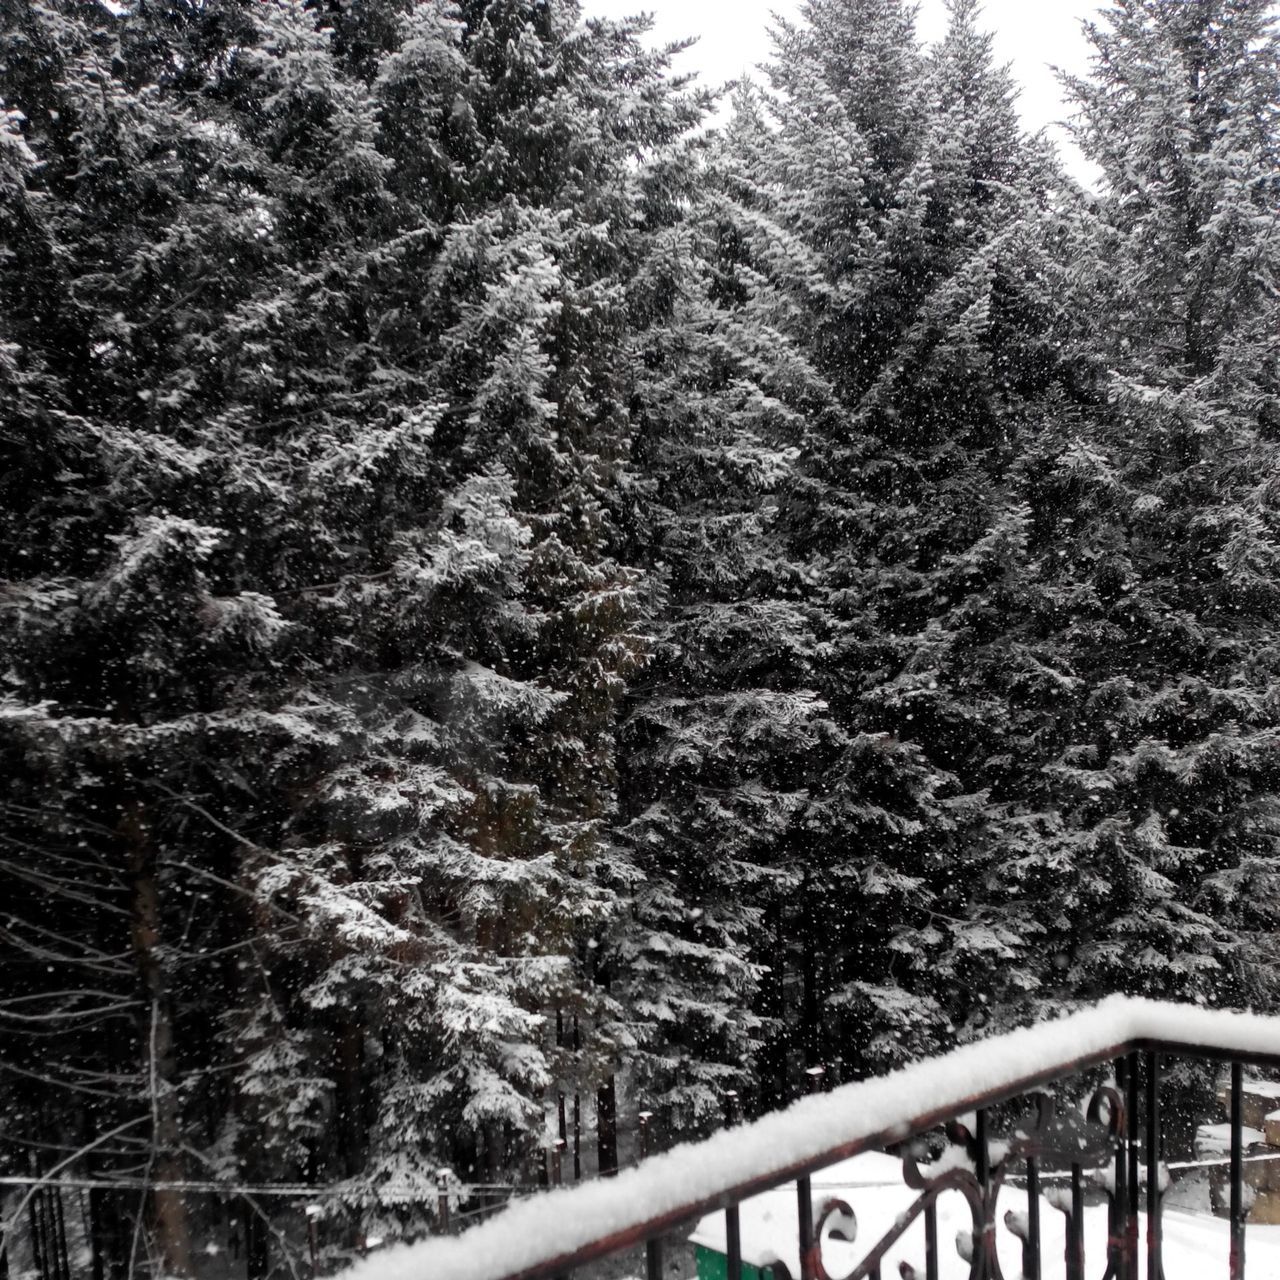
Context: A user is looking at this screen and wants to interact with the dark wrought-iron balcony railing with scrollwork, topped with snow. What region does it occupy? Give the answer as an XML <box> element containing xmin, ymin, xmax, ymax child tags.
<box><xmin>353</xmin><ymin>997</ymin><xmax>1280</xmax><ymax>1280</ymax></box>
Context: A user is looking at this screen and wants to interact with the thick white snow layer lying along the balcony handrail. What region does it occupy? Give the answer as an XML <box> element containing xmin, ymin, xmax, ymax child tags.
<box><xmin>337</xmin><ymin>996</ymin><xmax>1280</xmax><ymax>1280</ymax></box>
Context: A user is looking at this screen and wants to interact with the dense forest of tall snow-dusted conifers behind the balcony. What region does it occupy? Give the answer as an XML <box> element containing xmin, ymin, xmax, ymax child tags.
<box><xmin>0</xmin><ymin>0</ymin><xmax>1280</xmax><ymax>1280</ymax></box>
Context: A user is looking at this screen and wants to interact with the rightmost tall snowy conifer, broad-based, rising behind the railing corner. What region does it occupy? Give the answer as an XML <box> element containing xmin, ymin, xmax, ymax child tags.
<box><xmin>901</xmin><ymin>4</ymin><xmax>1275</xmax><ymax>1032</ymax></box>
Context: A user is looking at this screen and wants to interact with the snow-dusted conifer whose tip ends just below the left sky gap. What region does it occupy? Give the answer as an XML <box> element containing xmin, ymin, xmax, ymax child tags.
<box><xmin>608</xmin><ymin>80</ymin><xmax>841</xmax><ymax>1134</ymax></box>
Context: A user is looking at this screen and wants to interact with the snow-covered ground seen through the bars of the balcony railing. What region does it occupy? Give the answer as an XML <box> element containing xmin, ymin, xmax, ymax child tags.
<box><xmin>692</xmin><ymin>1152</ymin><xmax>1280</xmax><ymax>1280</ymax></box>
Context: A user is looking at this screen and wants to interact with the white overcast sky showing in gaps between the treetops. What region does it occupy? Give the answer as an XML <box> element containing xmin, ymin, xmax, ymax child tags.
<box><xmin>582</xmin><ymin>0</ymin><xmax>1102</xmax><ymax>172</ymax></box>
